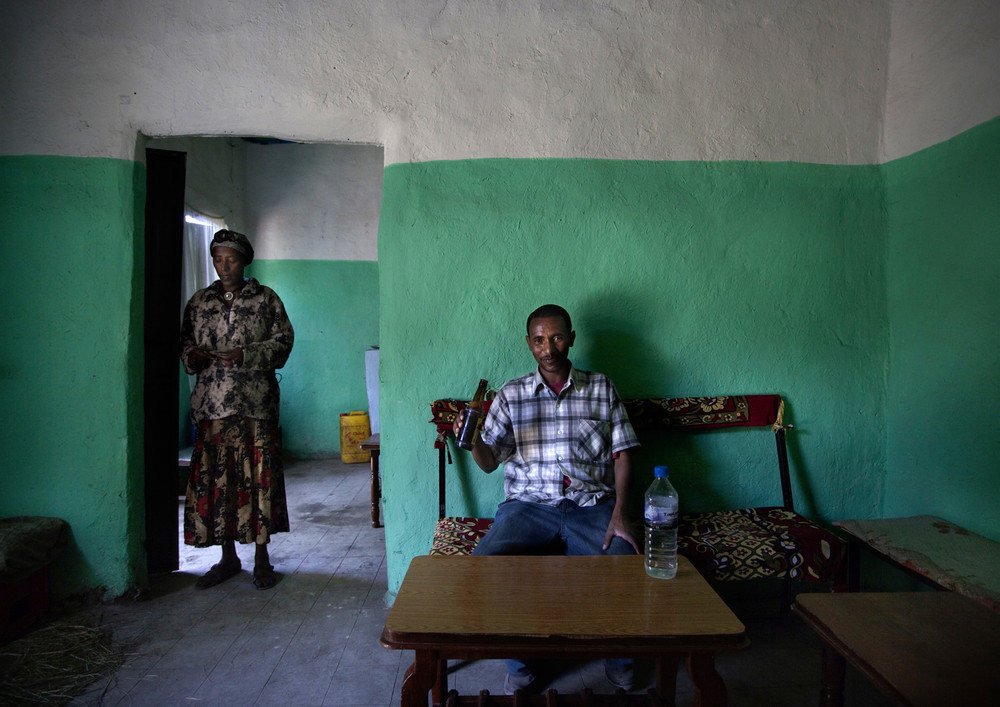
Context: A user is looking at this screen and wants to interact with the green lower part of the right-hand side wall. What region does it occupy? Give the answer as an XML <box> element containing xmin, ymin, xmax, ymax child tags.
<box><xmin>885</xmin><ymin>119</ymin><xmax>1000</xmax><ymax>540</ymax></box>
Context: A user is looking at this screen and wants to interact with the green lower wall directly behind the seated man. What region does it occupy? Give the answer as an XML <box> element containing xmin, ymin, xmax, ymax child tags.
<box><xmin>379</xmin><ymin>160</ymin><xmax>888</xmax><ymax>589</ymax></box>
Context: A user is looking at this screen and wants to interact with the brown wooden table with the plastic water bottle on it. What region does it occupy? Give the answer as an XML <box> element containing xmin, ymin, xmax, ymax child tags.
<box><xmin>382</xmin><ymin>555</ymin><xmax>747</xmax><ymax>707</ymax></box>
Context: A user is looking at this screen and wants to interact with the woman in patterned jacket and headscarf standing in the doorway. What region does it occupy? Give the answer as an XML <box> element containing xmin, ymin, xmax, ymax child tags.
<box><xmin>181</xmin><ymin>230</ymin><xmax>295</xmax><ymax>589</ymax></box>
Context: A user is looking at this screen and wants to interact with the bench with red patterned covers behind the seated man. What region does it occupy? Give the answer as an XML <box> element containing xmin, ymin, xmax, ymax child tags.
<box><xmin>430</xmin><ymin>395</ymin><xmax>847</xmax><ymax>596</ymax></box>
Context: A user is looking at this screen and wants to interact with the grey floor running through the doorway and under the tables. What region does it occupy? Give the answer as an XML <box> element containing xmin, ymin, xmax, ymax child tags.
<box><xmin>64</xmin><ymin>460</ymin><xmax>889</xmax><ymax>707</ymax></box>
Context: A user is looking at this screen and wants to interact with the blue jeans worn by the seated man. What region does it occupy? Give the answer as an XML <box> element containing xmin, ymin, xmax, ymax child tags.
<box><xmin>472</xmin><ymin>501</ymin><xmax>635</xmax><ymax>677</ymax></box>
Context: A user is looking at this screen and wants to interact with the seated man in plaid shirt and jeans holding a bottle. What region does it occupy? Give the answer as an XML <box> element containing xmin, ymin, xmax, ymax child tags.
<box><xmin>454</xmin><ymin>304</ymin><xmax>639</xmax><ymax>695</ymax></box>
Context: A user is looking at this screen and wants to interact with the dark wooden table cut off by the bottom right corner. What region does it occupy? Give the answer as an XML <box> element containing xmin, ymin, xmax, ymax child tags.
<box><xmin>793</xmin><ymin>592</ymin><xmax>1000</xmax><ymax>707</ymax></box>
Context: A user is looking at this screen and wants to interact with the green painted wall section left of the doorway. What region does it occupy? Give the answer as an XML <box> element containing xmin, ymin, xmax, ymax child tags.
<box><xmin>0</xmin><ymin>157</ymin><xmax>145</xmax><ymax>596</ymax></box>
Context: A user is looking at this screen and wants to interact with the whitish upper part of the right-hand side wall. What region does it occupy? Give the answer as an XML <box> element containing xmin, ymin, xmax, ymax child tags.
<box><xmin>883</xmin><ymin>0</ymin><xmax>1000</xmax><ymax>160</ymax></box>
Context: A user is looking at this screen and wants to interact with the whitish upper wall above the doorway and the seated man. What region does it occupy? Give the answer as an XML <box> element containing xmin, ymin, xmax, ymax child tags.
<box><xmin>0</xmin><ymin>0</ymin><xmax>892</xmax><ymax>163</ymax></box>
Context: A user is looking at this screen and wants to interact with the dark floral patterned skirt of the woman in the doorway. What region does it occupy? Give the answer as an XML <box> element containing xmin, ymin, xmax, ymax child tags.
<box><xmin>184</xmin><ymin>416</ymin><xmax>288</xmax><ymax>547</ymax></box>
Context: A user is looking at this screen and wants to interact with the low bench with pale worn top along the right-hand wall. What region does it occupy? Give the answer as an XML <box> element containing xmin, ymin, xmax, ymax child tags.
<box><xmin>836</xmin><ymin>515</ymin><xmax>1000</xmax><ymax>612</ymax></box>
